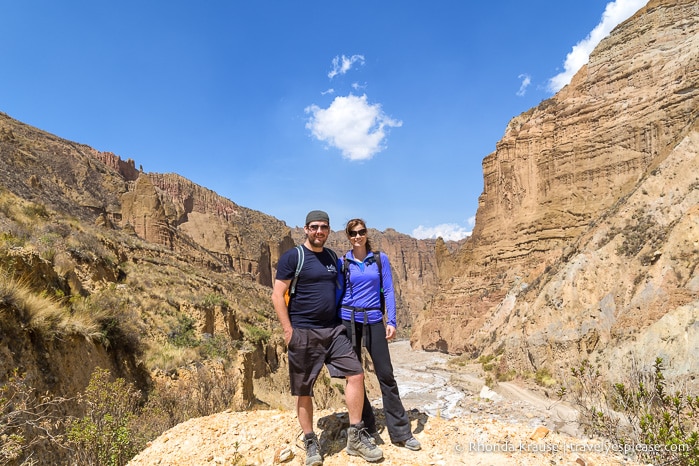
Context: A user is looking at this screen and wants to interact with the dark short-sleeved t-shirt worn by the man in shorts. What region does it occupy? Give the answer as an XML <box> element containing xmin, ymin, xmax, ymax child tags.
<box><xmin>276</xmin><ymin>246</ymin><xmax>340</xmax><ymax>328</ymax></box>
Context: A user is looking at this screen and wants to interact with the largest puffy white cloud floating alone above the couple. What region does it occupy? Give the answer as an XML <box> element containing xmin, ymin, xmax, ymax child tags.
<box><xmin>306</xmin><ymin>94</ymin><xmax>403</xmax><ymax>160</ymax></box>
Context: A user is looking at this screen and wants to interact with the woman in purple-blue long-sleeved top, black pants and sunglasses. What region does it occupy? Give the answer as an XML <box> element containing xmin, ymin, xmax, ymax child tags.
<box><xmin>340</xmin><ymin>218</ymin><xmax>420</xmax><ymax>450</ymax></box>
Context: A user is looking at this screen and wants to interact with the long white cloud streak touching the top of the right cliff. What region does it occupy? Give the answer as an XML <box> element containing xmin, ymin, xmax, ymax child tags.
<box><xmin>548</xmin><ymin>0</ymin><xmax>648</xmax><ymax>92</ymax></box>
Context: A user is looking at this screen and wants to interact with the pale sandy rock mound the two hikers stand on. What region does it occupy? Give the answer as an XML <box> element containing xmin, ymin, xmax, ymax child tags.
<box><xmin>129</xmin><ymin>407</ymin><xmax>642</xmax><ymax>466</ymax></box>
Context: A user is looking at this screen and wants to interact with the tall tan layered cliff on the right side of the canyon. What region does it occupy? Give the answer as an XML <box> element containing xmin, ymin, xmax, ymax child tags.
<box><xmin>412</xmin><ymin>0</ymin><xmax>699</xmax><ymax>380</ymax></box>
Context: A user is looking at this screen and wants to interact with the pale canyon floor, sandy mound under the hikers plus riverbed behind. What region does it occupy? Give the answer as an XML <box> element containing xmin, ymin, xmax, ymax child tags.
<box><xmin>129</xmin><ymin>341</ymin><xmax>641</xmax><ymax>466</ymax></box>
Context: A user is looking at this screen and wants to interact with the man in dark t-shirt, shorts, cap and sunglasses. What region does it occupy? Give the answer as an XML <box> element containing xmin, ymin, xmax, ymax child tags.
<box><xmin>272</xmin><ymin>210</ymin><xmax>383</xmax><ymax>466</ymax></box>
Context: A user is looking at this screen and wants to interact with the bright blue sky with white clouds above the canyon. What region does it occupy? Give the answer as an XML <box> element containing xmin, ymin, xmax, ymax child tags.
<box><xmin>0</xmin><ymin>0</ymin><xmax>646</xmax><ymax>239</ymax></box>
